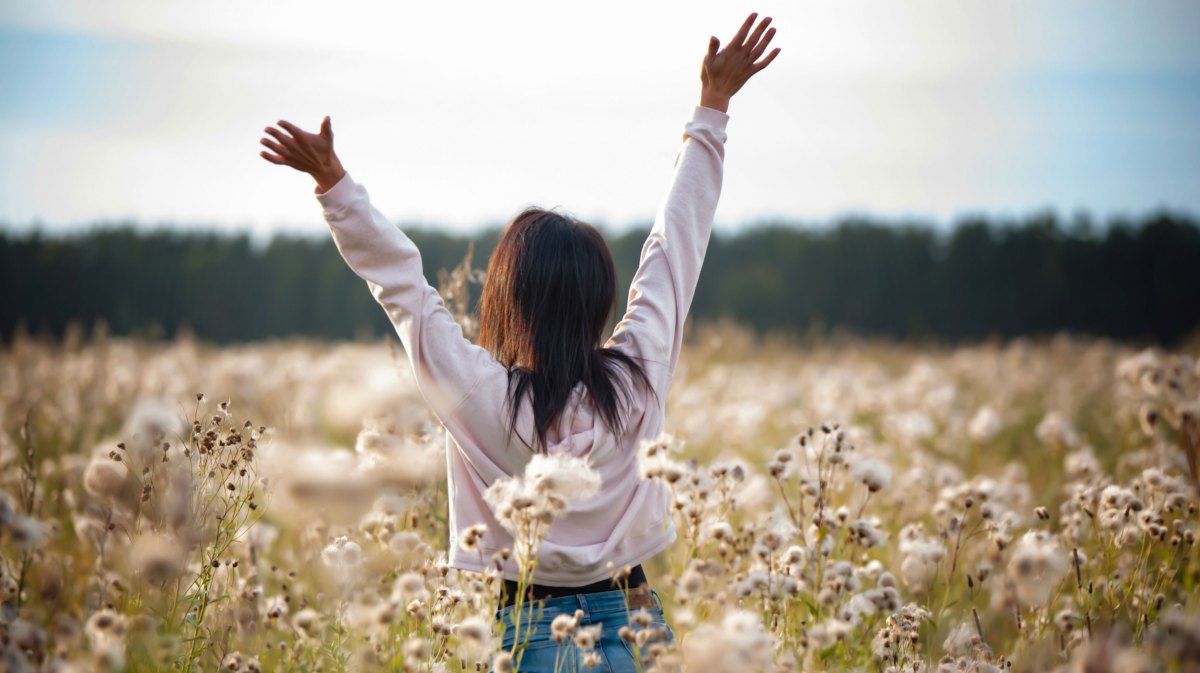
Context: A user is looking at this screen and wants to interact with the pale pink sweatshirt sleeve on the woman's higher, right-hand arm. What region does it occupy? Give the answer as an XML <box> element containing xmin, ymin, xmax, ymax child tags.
<box><xmin>607</xmin><ymin>107</ymin><xmax>730</xmax><ymax>399</ymax></box>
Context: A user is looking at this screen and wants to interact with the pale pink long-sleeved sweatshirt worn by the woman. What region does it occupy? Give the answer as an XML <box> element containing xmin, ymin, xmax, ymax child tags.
<box><xmin>317</xmin><ymin>107</ymin><xmax>728</xmax><ymax>587</ymax></box>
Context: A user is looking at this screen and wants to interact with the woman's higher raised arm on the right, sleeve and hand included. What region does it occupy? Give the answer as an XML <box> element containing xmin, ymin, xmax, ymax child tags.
<box><xmin>607</xmin><ymin>14</ymin><xmax>779</xmax><ymax>399</ymax></box>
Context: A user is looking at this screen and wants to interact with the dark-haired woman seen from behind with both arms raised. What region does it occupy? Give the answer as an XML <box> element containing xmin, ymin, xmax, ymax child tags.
<box><xmin>262</xmin><ymin>14</ymin><xmax>779</xmax><ymax>671</ymax></box>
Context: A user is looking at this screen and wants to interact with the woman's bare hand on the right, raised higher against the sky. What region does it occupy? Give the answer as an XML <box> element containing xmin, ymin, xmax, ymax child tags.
<box><xmin>700</xmin><ymin>13</ymin><xmax>779</xmax><ymax>112</ymax></box>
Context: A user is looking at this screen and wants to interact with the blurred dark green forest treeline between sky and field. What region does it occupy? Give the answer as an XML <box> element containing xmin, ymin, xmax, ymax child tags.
<box><xmin>0</xmin><ymin>212</ymin><xmax>1200</xmax><ymax>344</ymax></box>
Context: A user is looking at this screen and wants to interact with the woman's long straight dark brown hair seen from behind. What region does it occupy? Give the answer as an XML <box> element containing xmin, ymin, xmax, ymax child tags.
<box><xmin>479</xmin><ymin>208</ymin><xmax>653</xmax><ymax>450</ymax></box>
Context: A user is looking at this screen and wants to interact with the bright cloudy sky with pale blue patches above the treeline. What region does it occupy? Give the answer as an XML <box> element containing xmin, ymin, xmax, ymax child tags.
<box><xmin>0</xmin><ymin>0</ymin><xmax>1200</xmax><ymax>234</ymax></box>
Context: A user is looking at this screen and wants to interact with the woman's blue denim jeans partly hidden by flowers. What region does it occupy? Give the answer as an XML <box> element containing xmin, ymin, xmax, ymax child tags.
<box><xmin>497</xmin><ymin>590</ymin><xmax>674</xmax><ymax>673</ymax></box>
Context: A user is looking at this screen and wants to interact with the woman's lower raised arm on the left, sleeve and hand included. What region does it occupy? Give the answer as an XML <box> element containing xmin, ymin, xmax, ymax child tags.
<box><xmin>262</xmin><ymin>118</ymin><xmax>500</xmax><ymax>422</ymax></box>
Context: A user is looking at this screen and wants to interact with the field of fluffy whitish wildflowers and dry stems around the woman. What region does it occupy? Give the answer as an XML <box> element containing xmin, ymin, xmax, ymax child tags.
<box><xmin>0</xmin><ymin>328</ymin><xmax>1200</xmax><ymax>672</ymax></box>
